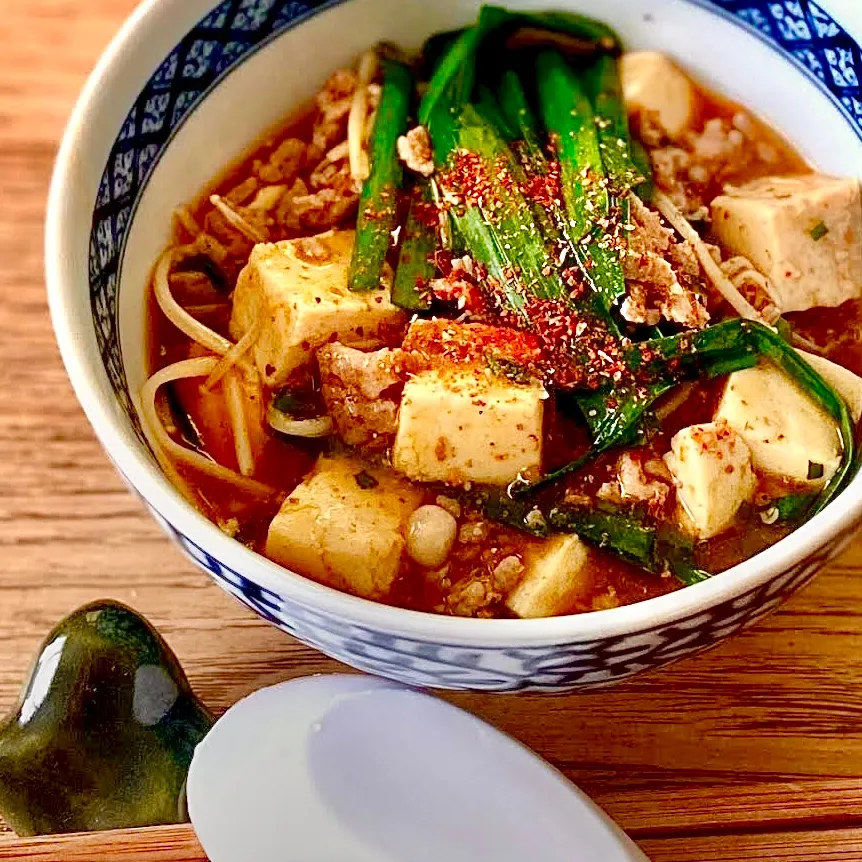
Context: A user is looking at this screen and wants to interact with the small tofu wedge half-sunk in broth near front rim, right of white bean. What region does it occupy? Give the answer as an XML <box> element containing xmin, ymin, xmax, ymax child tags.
<box><xmin>506</xmin><ymin>536</ymin><xmax>593</xmax><ymax>618</ymax></box>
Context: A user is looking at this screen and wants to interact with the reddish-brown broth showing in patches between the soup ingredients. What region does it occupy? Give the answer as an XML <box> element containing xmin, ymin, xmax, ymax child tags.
<box><xmin>149</xmin><ymin>64</ymin><xmax>836</xmax><ymax>616</ymax></box>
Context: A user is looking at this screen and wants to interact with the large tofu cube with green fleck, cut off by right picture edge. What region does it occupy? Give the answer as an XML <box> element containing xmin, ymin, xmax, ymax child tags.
<box><xmin>712</xmin><ymin>174</ymin><xmax>862</xmax><ymax>311</ymax></box>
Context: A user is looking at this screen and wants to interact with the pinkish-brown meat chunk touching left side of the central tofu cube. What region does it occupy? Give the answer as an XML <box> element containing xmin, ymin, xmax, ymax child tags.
<box><xmin>317</xmin><ymin>342</ymin><xmax>405</xmax><ymax>451</ymax></box>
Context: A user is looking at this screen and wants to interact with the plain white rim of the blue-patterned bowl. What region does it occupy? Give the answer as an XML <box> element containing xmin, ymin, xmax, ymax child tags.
<box><xmin>45</xmin><ymin>0</ymin><xmax>862</xmax><ymax>647</ymax></box>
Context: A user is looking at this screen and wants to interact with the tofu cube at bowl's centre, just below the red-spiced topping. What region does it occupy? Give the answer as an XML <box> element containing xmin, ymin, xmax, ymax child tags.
<box><xmin>392</xmin><ymin>365</ymin><xmax>547</xmax><ymax>485</ymax></box>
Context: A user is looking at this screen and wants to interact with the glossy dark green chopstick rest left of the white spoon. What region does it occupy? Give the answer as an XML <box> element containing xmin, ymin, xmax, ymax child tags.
<box><xmin>0</xmin><ymin>601</ymin><xmax>213</xmax><ymax>836</ymax></box>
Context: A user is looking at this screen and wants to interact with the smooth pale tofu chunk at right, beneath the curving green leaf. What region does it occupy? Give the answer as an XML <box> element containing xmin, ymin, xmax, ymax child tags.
<box><xmin>716</xmin><ymin>363</ymin><xmax>841</xmax><ymax>485</ymax></box>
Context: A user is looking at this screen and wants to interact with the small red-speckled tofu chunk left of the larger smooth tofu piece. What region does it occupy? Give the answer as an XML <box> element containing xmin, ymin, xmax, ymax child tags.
<box><xmin>665</xmin><ymin>421</ymin><xmax>757</xmax><ymax>539</ymax></box>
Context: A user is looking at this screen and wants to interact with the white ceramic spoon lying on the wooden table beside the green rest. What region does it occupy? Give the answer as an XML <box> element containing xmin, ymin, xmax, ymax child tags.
<box><xmin>188</xmin><ymin>676</ymin><xmax>647</xmax><ymax>862</ymax></box>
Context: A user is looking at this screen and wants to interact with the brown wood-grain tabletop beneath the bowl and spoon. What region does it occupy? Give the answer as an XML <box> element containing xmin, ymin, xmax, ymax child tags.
<box><xmin>5</xmin><ymin>0</ymin><xmax>862</xmax><ymax>862</ymax></box>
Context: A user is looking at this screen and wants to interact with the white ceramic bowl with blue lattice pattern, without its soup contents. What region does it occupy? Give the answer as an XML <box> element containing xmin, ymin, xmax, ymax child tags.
<box><xmin>47</xmin><ymin>0</ymin><xmax>862</xmax><ymax>691</ymax></box>
